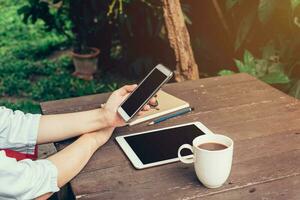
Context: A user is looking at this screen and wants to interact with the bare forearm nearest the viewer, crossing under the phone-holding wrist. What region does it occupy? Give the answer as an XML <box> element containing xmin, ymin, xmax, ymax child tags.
<box><xmin>48</xmin><ymin>128</ymin><xmax>113</xmax><ymax>187</ymax></box>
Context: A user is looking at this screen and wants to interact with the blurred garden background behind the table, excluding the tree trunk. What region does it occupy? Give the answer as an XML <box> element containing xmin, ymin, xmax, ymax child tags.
<box><xmin>0</xmin><ymin>0</ymin><xmax>300</xmax><ymax>113</ymax></box>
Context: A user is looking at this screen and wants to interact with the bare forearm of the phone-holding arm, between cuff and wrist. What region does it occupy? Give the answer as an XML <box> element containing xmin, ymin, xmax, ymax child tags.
<box><xmin>37</xmin><ymin>109</ymin><xmax>110</xmax><ymax>144</ymax></box>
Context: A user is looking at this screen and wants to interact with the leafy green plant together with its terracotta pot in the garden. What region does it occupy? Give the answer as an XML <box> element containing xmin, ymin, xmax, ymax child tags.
<box><xmin>18</xmin><ymin>0</ymin><xmax>100</xmax><ymax>80</ymax></box>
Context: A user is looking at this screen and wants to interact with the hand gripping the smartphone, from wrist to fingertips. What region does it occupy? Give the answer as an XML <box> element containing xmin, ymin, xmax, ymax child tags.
<box><xmin>103</xmin><ymin>84</ymin><xmax>156</xmax><ymax>127</ymax></box>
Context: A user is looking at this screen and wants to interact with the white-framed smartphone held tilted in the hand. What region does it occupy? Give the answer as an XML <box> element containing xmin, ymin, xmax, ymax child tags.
<box><xmin>118</xmin><ymin>64</ymin><xmax>173</xmax><ymax>122</ymax></box>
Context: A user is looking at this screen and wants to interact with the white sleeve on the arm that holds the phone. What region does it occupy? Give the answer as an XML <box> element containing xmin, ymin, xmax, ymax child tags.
<box><xmin>0</xmin><ymin>107</ymin><xmax>41</xmax><ymax>154</ymax></box>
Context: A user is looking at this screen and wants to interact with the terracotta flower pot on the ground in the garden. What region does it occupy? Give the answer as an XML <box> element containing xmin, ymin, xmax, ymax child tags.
<box><xmin>72</xmin><ymin>47</ymin><xmax>100</xmax><ymax>80</ymax></box>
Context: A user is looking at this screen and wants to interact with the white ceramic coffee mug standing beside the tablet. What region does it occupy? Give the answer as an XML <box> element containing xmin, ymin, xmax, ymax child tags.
<box><xmin>178</xmin><ymin>134</ymin><xmax>233</xmax><ymax>188</ymax></box>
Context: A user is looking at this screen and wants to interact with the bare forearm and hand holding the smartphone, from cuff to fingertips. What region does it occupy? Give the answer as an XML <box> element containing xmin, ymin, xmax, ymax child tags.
<box><xmin>37</xmin><ymin>85</ymin><xmax>156</xmax><ymax>144</ymax></box>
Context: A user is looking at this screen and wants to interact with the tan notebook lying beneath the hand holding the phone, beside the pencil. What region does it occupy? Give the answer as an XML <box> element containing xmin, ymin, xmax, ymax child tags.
<box><xmin>128</xmin><ymin>90</ymin><xmax>190</xmax><ymax>126</ymax></box>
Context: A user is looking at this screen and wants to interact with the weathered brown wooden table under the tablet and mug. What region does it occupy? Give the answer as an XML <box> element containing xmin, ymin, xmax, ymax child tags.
<box><xmin>41</xmin><ymin>74</ymin><xmax>300</xmax><ymax>200</ymax></box>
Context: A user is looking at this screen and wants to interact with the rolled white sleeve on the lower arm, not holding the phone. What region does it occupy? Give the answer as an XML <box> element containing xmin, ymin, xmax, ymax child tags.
<box><xmin>0</xmin><ymin>151</ymin><xmax>59</xmax><ymax>200</ymax></box>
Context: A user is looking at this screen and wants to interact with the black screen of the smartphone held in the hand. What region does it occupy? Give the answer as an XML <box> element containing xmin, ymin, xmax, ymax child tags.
<box><xmin>121</xmin><ymin>68</ymin><xmax>167</xmax><ymax>117</ymax></box>
